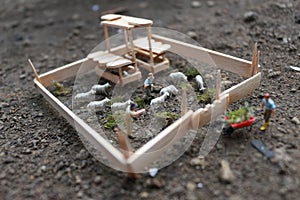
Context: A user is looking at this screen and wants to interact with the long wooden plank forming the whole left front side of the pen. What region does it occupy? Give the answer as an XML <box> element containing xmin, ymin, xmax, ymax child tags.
<box><xmin>34</xmin><ymin>79</ymin><xmax>127</xmax><ymax>170</ymax></box>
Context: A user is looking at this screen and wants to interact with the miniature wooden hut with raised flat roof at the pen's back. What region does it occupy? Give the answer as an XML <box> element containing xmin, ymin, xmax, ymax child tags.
<box><xmin>88</xmin><ymin>14</ymin><xmax>170</xmax><ymax>85</ymax></box>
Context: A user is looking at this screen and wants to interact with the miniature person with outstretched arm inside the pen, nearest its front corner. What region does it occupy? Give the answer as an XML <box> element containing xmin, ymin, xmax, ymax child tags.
<box><xmin>125</xmin><ymin>103</ymin><xmax>146</xmax><ymax>139</ymax></box>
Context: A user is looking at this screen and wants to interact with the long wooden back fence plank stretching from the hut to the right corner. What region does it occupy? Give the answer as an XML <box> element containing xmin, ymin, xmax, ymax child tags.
<box><xmin>152</xmin><ymin>35</ymin><xmax>258</xmax><ymax>78</ymax></box>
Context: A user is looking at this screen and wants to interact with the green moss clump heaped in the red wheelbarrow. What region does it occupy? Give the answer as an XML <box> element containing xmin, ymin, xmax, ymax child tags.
<box><xmin>227</xmin><ymin>102</ymin><xmax>253</xmax><ymax>123</ymax></box>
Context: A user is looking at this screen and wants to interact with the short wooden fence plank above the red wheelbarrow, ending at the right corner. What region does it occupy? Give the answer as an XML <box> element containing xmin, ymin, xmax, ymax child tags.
<box><xmin>221</xmin><ymin>72</ymin><xmax>261</xmax><ymax>104</ymax></box>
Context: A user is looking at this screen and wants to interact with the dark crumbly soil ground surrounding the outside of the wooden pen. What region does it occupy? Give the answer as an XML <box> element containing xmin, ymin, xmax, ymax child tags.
<box><xmin>0</xmin><ymin>0</ymin><xmax>300</xmax><ymax>199</ymax></box>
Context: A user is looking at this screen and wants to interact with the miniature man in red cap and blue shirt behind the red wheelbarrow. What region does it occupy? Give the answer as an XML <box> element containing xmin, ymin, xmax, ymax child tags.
<box><xmin>260</xmin><ymin>93</ymin><xmax>276</xmax><ymax>131</ymax></box>
